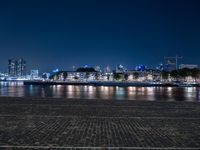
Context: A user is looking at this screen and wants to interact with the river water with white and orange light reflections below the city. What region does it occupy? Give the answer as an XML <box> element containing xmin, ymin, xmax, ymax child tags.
<box><xmin>0</xmin><ymin>82</ymin><xmax>200</xmax><ymax>101</ymax></box>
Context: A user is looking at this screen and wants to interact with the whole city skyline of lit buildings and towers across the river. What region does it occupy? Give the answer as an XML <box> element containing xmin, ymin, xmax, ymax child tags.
<box><xmin>0</xmin><ymin>57</ymin><xmax>198</xmax><ymax>82</ymax></box>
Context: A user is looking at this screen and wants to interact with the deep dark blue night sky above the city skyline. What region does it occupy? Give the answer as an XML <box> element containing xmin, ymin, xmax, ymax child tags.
<box><xmin>0</xmin><ymin>0</ymin><xmax>200</xmax><ymax>71</ymax></box>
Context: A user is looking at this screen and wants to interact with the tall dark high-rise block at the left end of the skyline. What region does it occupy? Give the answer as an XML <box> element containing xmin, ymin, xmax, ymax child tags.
<box><xmin>8</xmin><ymin>58</ymin><xmax>26</xmax><ymax>77</ymax></box>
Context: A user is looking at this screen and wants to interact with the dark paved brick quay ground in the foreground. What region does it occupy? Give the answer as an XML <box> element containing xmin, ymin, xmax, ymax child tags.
<box><xmin>0</xmin><ymin>98</ymin><xmax>200</xmax><ymax>150</ymax></box>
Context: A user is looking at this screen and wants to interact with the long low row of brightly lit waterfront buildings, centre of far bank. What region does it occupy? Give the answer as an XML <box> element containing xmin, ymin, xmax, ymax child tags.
<box><xmin>50</xmin><ymin>65</ymin><xmax>161</xmax><ymax>82</ymax></box>
